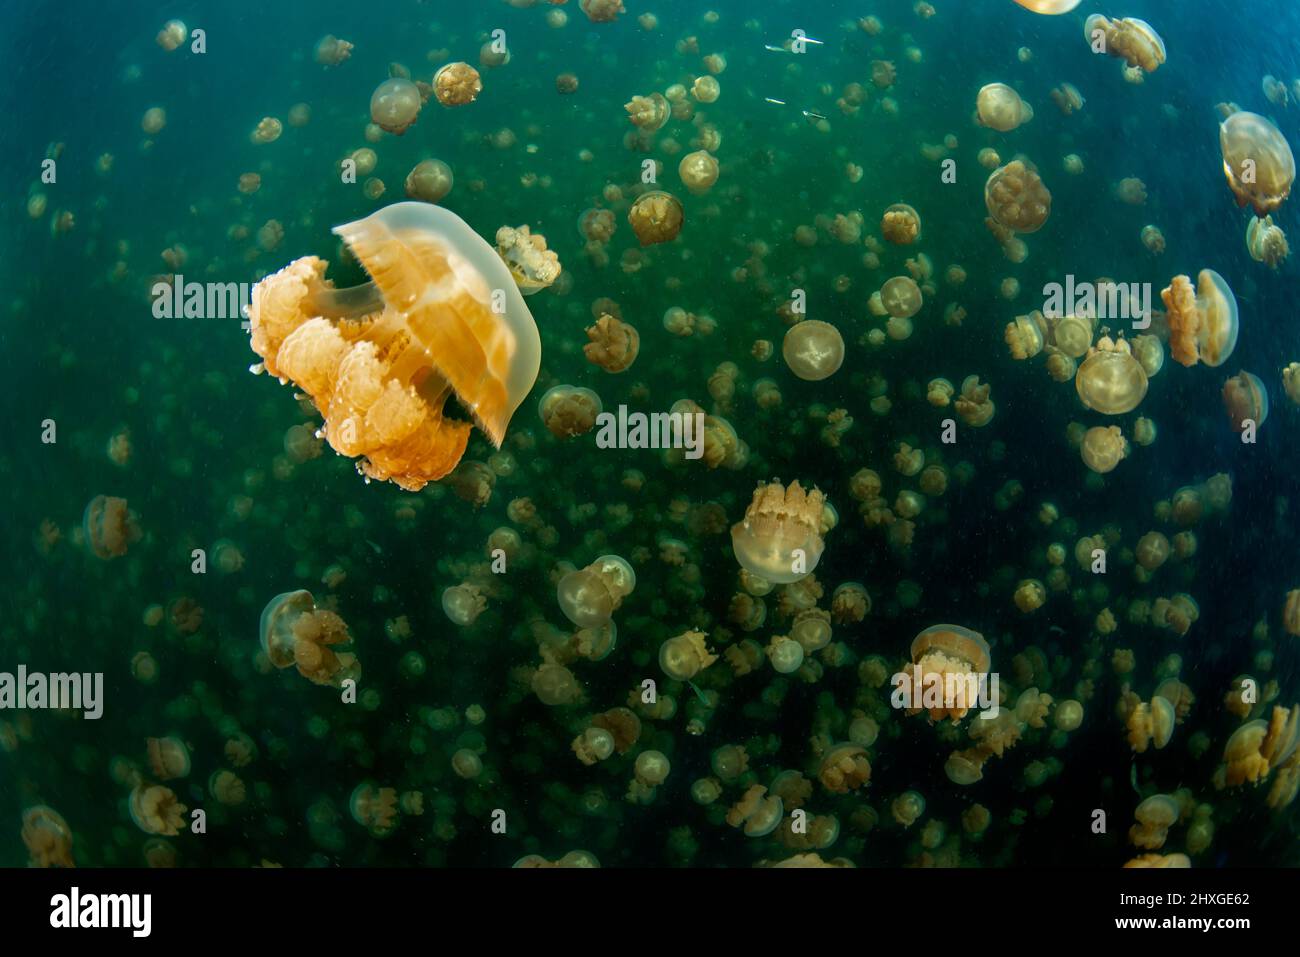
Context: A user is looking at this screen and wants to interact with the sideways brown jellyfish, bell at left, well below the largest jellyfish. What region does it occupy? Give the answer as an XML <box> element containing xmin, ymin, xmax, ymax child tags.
<box><xmin>259</xmin><ymin>589</ymin><xmax>360</xmax><ymax>688</ymax></box>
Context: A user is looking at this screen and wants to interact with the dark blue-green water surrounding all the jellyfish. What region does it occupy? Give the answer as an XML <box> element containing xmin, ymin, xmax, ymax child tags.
<box><xmin>0</xmin><ymin>0</ymin><xmax>1300</xmax><ymax>866</ymax></box>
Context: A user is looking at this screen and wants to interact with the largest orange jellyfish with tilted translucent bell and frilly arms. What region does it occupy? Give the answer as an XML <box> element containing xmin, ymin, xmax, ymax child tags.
<box><xmin>248</xmin><ymin>203</ymin><xmax>541</xmax><ymax>492</ymax></box>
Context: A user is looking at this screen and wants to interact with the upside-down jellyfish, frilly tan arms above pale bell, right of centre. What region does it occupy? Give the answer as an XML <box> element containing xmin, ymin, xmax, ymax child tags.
<box><xmin>732</xmin><ymin>481</ymin><xmax>826</xmax><ymax>585</ymax></box>
